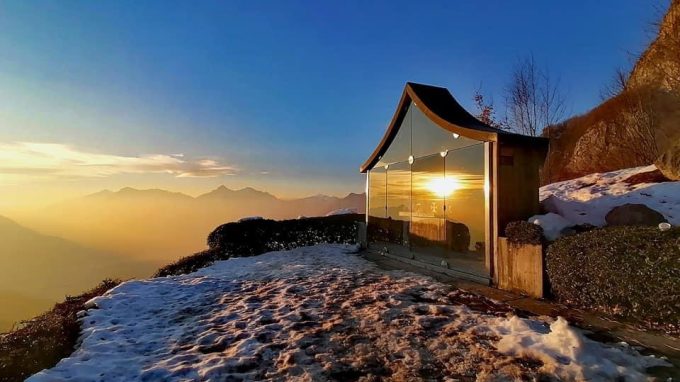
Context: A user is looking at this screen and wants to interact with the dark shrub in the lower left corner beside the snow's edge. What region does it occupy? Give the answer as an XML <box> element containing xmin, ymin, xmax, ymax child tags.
<box><xmin>0</xmin><ymin>280</ymin><xmax>120</xmax><ymax>381</ymax></box>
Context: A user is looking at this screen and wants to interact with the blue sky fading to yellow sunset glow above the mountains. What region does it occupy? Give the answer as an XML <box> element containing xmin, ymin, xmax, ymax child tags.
<box><xmin>0</xmin><ymin>0</ymin><xmax>665</xmax><ymax>212</ymax></box>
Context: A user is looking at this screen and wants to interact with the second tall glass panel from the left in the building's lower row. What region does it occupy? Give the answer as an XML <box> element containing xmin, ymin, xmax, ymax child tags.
<box><xmin>387</xmin><ymin>161</ymin><xmax>411</xmax><ymax>244</ymax></box>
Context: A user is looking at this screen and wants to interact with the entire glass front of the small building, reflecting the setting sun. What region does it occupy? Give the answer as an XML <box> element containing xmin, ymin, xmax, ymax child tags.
<box><xmin>369</xmin><ymin>104</ymin><xmax>488</xmax><ymax>277</ymax></box>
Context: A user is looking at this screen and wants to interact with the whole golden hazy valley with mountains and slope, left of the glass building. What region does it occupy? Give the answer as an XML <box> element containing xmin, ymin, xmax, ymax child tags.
<box><xmin>0</xmin><ymin>186</ymin><xmax>365</xmax><ymax>330</ymax></box>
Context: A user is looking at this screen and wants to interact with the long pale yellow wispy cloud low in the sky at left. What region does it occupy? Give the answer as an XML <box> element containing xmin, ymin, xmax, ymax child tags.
<box><xmin>0</xmin><ymin>142</ymin><xmax>238</xmax><ymax>178</ymax></box>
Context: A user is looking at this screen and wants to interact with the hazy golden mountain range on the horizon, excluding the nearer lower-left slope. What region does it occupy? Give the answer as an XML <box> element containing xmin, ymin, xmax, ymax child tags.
<box><xmin>14</xmin><ymin>186</ymin><xmax>365</xmax><ymax>266</ymax></box>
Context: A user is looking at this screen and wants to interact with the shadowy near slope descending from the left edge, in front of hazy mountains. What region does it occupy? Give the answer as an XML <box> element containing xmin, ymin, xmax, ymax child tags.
<box><xmin>0</xmin><ymin>216</ymin><xmax>147</xmax><ymax>332</ymax></box>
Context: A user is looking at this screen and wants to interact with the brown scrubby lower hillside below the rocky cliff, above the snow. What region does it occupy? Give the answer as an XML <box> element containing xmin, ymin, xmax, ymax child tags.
<box><xmin>542</xmin><ymin>88</ymin><xmax>676</xmax><ymax>184</ymax></box>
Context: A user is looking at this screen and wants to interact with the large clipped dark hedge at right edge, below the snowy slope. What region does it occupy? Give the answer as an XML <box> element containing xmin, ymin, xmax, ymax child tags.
<box><xmin>546</xmin><ymin>227</ymin><xmax>680</xmax><ymax>334</ymax></box>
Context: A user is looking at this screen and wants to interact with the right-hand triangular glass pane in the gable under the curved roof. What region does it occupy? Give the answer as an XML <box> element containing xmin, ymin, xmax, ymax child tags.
<box><xmin>411</xmin><ymin>103</ymin><xmax>479</xmax><ymax>158</ymax></box>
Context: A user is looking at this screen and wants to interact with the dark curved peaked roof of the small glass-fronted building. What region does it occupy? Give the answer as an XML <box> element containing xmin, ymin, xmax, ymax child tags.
<box><xmin>360</xmin><ymin>82</ymin><xmax>547</xmax><ymax>172</ymax></box>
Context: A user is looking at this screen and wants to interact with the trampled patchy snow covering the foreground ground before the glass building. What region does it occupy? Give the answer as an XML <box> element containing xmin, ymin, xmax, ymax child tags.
<box><xmin>29</xmin><ymin>245</ymin><xmax>664</xmax><ymax>382</ymax></box>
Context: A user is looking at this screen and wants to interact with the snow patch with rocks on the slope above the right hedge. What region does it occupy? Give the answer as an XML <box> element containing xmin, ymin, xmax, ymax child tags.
<box><xmin>540</xmin><ymin>165</ymin><xmax>680</xmax><ymax>226</ymax></box>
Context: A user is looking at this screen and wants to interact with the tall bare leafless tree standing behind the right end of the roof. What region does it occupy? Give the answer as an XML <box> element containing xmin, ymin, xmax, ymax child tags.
<box><xmin>505</xmin><ymin>56</ymin><xmax>566</xmax><ymax>136</ymax></box>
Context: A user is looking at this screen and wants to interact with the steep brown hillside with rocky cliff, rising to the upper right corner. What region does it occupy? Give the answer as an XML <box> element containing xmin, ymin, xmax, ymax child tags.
<box><xmin>542</xmin><ymin>0</ymin><xmax>680</xmax><ymax>184</ymax></box>
